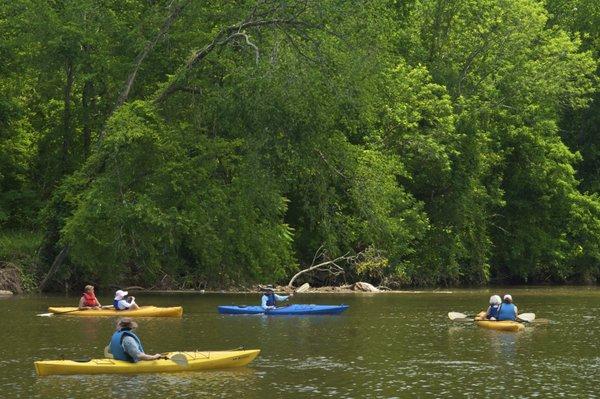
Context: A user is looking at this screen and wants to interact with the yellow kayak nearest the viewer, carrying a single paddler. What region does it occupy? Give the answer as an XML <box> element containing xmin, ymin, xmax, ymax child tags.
<box><xmin>34</xmin><ymin>349</ymin><xmax>260</xmax><ymax>375</ymax></box>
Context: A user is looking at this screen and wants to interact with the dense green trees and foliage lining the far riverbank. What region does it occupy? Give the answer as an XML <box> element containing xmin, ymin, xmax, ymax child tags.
<box><xmin>0</xmin><ymin>0</ymin><xmax>600</xmax><ymax>287</ymax></box>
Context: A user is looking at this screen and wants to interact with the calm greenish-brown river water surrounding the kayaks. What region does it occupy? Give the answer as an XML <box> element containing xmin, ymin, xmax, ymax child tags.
<box><xmin>0</xmin><ymin>287</ymin><xmax>600</xmax><ymax>399</ymax></box>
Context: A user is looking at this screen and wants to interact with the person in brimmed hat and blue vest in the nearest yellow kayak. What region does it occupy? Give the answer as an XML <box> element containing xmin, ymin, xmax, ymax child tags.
<box><xmin>109</xmin><ymin>317</ymin><xmax>164</xmax><ymax>363</ymax></box>
